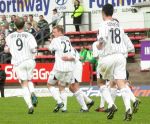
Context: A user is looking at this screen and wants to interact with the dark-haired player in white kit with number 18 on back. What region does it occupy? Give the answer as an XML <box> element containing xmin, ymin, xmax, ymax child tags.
<box><xmin>97</xmin><ymin>4</ymin><xmax>135</xmax><ymax>120</ymax></box>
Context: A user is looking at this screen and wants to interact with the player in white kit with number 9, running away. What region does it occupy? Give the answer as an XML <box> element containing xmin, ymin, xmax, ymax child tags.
<box><xmin>5</xmin><ymin>17</ymin><xmax>38</xmax><ymax>114</ymax></box>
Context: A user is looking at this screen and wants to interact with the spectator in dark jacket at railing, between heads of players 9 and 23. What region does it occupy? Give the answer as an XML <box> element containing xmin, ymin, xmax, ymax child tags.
<box><xmin>37</xmin><ymin>15</ymin><xmax>50</xmax><ymax>41</ymax></box>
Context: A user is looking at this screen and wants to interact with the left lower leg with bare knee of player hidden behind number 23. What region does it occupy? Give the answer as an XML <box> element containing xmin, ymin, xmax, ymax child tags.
<box><xmin>69</xmin><ymin>83</ymin><xmax>88</xmax><ymax>112</ymax></box>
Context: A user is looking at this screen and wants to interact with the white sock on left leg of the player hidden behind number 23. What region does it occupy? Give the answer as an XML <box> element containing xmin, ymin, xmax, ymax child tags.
<box><xmin>74</xmin><ymin>89</ymin><xmax>88</xmax><ymax>110</ymax></box>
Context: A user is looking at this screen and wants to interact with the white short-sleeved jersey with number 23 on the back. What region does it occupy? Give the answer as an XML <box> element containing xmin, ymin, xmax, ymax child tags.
<box><xmin>49</xmin><ymin>36</ymin><xmax>75</xmax><ymax>72</ymax></box>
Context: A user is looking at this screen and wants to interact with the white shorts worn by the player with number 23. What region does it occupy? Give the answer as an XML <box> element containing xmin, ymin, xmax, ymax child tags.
<box><xmin>48</xmin><ymin>70</ymin><xmax>73</xmax><ymax>86</ymax></box>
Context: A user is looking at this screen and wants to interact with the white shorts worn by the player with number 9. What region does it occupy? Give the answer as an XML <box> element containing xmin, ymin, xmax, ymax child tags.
<box><xmin>14</xmin><ymin>59</ymin><xmax>36</xmax><ymax>81</ymax></box>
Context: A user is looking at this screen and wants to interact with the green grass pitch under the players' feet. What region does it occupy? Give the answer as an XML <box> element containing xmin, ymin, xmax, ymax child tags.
<box><xmin>0</xmin><ymin>97</ymin><xmax>150</xmax><ymax>124</ymax></box>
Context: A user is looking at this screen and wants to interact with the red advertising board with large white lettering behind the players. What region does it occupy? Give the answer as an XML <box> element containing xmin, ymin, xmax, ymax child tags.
<box><xmin>1</xmin><ymin>62</ymin><xmax>92</xmax><ymax>84</ymax></box>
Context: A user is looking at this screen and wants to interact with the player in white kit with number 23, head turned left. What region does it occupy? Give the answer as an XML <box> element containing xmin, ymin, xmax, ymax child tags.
<box><xmin>47</xmin><ymin>25</ymin><xmax>88</xmax><ymax>112</ymax></box>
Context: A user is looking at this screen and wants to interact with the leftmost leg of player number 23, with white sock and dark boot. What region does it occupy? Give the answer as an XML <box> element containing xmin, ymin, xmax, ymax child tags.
<box><xmin>47</xmin><ymin>83</ymin><xmax>64</xmax><ymax>112</ymax></box>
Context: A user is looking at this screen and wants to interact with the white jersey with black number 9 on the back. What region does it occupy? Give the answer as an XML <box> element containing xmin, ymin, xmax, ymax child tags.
<box><xmin>6</xmin><ymin>32</ymin><xmax>37</xmax><ymax>65</ymax></box>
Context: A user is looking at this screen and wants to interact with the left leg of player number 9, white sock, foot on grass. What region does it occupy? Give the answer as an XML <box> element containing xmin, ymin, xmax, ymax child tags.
<box><xmin>21</xmin><ymin>81</ymin><xmax>34</xmax><ymax>114</ymax></box>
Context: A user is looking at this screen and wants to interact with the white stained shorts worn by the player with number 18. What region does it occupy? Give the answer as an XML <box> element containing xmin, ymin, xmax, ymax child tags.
<box><xmin>98</xmin><ymin>54</ymin><xmax>126</xmax><ymax>80</ymax></box>
